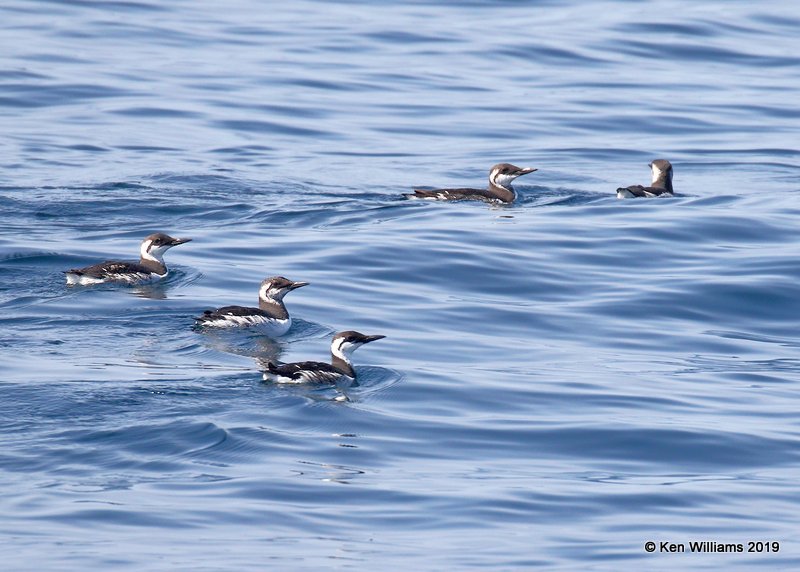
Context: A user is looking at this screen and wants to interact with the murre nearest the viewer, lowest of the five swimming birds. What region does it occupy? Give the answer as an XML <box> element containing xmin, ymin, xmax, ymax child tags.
<box><xmin>264</xmin><ymin>330</ymin><xmax>386</xmax><ymax>383</ymax></box>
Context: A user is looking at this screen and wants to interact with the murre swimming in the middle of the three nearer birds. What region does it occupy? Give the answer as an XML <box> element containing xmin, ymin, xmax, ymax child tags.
<box><xmin>195</xmin><ymin>276</ymin><xmax>308</xmax><ymax>336</ymax></box>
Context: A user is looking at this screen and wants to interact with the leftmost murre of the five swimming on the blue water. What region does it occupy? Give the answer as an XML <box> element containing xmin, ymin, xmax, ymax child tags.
<box><xmin>64</xmin><ymin>232</ymin><xmax>192</xmax><ymax>285</ymax></box>
